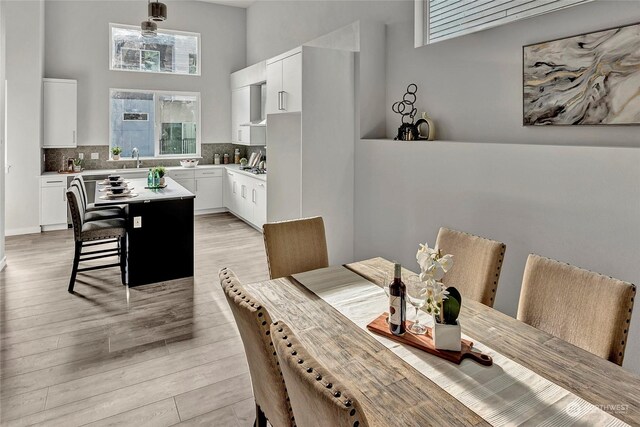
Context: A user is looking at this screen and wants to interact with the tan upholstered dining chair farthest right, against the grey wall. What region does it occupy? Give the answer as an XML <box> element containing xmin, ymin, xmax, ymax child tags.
<box><xmin>517</xmin><ymin>254</ymin><xmax>636</xmax><ymax>365</ymax></box>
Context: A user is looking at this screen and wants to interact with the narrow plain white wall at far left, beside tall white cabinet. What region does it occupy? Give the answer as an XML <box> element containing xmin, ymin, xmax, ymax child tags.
<box><xmin>4</xmin><ymin>1</ymin><xmax>44</xmax><ymax>235</ymax></box>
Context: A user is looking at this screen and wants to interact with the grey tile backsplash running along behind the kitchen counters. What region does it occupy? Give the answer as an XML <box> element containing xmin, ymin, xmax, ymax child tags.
<box><xmin>43</xmin><ymin>144</ymin><xmax>265</xmax><ymax>172</ymax></box>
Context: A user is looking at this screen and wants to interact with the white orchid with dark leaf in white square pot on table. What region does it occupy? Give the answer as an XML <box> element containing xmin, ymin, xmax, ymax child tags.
<box><xmin>416</xmin><ymin>243</ymin><xmax>462</xmax><ymax>351</ymax></box>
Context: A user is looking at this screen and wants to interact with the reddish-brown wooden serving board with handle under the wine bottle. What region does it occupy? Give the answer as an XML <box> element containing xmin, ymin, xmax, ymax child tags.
<box><xmin>367</xmin><ymin>313</ymin><xmax>493</xmax><ymax>366</ymax></box>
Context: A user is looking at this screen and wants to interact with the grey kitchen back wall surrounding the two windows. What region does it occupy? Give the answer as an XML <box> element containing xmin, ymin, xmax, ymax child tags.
<box><xmin>45</xmin><ymin>1</ymin><xmax>246</xmax><ymax>147</ymax></box>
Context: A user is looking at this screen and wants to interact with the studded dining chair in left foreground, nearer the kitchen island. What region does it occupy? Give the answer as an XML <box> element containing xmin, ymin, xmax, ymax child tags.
<box><xmin>218</xmin><ymin>268</ymin><xmax>295</xmax><ymax>427</ymax></box>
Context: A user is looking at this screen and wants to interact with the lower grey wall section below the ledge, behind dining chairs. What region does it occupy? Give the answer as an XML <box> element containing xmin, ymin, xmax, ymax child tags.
<box><xmin>355</xmin><ymin>140</ymin><xmax>640</xmax><ymax>372</ymax></box>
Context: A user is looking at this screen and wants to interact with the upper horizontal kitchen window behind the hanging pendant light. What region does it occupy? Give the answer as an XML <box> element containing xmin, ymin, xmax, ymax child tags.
<box><xmin>109</xmin><ymin>24</ymin><xmax>200</xmax><ymax>76</ymax></box>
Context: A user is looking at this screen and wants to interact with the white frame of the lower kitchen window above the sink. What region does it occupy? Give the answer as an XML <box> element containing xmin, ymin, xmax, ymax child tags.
<box><xmin>109</xmin><ymin>88</ymin><xmax>202</xmax><ymax>160</ymax></box>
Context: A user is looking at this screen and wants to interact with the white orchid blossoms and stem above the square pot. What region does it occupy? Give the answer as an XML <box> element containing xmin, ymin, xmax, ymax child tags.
<box><xmin>416</xmin><ymin>243</ymin><xmax>453</xmax><ymax>322</ymax></box>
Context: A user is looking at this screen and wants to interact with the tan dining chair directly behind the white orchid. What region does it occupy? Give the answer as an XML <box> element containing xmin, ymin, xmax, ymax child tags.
<box><xmin>436</xmin><ymin>227</ymin><xmax>506</xmax><ymax>307</ymax></box>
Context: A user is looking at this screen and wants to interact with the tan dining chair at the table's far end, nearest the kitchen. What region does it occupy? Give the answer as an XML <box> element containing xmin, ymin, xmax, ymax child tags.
<box><xmin>262</xmin><ymin>216</ymin><xmax>329</xmax><ymax>279</ymax></box>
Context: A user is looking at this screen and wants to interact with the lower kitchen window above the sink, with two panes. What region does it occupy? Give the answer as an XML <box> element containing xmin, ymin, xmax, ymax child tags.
<box><xmin>109</xmin><ymin>89</ymin><xmax>200</xmax><ymax>157</ymax></box>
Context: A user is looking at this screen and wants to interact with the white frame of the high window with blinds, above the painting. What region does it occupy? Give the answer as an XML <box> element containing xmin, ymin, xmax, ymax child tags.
<box><xmin>414</xmin><ymin>0</ymin><xmax>593</xmax><ymax>47</ymax></box>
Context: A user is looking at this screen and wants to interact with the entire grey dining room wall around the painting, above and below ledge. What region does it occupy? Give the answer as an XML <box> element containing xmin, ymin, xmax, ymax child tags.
<box><xmin>247</xmin><ymin>1</ymin><xmax>640</xmax><ymax>372</ymax></box>
